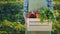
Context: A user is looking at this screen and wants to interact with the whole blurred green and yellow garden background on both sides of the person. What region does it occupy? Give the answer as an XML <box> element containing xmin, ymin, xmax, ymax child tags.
<box><xmin>0</xmin><ymin>0</ymin><xmax>60</xmax><ymax>34</ymax></box>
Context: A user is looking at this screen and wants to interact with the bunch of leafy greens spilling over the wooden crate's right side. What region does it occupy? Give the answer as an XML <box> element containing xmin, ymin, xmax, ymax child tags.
<box><xmin>40</xmin><ymin>8</ymin><xmax>56</xmax><ymax>22</ymax></box>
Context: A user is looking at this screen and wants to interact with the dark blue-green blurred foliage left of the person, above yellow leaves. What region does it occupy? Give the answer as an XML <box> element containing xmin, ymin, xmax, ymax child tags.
<box><xmin>0</xmin><ymin>3</ymin><xmax>24</xmax><ymax>23</ymax></box>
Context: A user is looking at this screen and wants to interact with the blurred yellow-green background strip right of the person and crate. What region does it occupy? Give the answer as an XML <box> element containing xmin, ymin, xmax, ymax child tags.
<box><xmin>52</xmin><ymin>0</ymin><xmax>60</xmax><ymax>34</ymax></box>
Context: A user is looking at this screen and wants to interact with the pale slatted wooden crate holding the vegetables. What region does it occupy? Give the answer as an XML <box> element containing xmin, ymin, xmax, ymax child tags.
<box><xmin>26</xmin><ymin>18</ymin><xmax>52</xmax><ymax>31</ymax></box>
